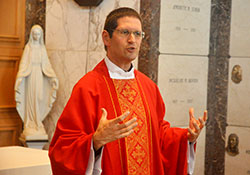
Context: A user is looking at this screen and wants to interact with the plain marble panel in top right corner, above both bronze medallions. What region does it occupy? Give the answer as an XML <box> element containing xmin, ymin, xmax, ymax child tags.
<box><xmin>230</xmin><ymin>0</ymin><xmax>250</xmax><ymax>57</ymax></box>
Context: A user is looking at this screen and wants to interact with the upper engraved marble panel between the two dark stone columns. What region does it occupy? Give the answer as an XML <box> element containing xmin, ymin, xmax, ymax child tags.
<box><xmin>159</xmin><ymin>0</ymin><xmax>211</xmax><ymax>55</ymax></box>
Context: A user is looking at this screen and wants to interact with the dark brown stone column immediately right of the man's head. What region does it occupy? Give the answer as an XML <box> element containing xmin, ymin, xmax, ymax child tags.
<box><xmin>138</xmin><ymin>0</ymin><xmax>161</xmax><ymax>83</ymax></box>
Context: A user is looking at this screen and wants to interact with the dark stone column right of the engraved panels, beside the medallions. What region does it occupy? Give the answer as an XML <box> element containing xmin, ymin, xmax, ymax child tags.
<box><xmin>205</xmin><ymin>0</ymin><xmax>231</xmax><ymax>175</ymax></box>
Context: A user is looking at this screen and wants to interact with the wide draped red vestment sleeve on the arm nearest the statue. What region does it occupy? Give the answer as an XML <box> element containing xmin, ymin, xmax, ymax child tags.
<box><xmin>49</xmin><ymin>83</ymin><xmax>98</xmax><ymax>175</ymax></box>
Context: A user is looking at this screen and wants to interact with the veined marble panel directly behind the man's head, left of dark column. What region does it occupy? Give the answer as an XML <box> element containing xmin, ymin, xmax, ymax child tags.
<box><xmin>87</xmin><ymin>0</ymin><xmax>140</xmax><ymax>71</ymax></box>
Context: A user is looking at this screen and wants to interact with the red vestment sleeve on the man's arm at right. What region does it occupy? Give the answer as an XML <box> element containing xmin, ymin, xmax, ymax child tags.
<box><xmin>157</xmin><ymin>87</ymin><xmax>187</xmax><ymax>175</ymax></box>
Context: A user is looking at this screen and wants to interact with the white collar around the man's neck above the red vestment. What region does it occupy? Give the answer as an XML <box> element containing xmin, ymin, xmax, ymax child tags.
<box><xmin>104</xmin><ymin>56</ymin><xmax>135</xmax><ymax>79</ymax></box>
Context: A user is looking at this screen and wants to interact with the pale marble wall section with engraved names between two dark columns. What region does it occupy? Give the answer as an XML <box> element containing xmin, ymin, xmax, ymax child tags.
<box><xmin>158</xmin><ymin>0</ymin><xmax>211</xmax><ymax>175</ymax></box>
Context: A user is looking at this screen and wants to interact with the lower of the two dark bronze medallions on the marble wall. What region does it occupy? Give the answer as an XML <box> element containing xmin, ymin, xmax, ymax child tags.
<box><xmin>226</xmin><ymin>133</ymin><xmax>239</xmax><ymax>156</ymax></box>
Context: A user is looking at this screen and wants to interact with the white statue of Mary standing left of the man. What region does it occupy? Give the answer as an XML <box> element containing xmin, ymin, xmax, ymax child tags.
<box><xmin>15</xmin><ymin>25</ymin><xmax>58</xmax><ymax>140</ymax></box>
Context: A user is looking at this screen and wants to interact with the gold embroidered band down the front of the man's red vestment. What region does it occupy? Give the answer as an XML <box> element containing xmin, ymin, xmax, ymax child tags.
<box><xmin>113</xmin><ymin>79</ymin><xmax>150</xmax><ymax>175</ymax></box>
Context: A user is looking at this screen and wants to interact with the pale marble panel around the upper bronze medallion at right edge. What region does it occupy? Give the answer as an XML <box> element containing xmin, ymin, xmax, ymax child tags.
<box><xmin>227</xmin><ymin>58</ymin><xmax>250</xmax><ymax>126</ymax></box>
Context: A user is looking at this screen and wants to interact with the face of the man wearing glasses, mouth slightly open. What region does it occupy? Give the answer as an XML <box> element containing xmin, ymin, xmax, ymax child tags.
<box><xmin>107</xmin><ymin>16</ymin><xmax>142</xmax><ymax>66</ymax></box>
